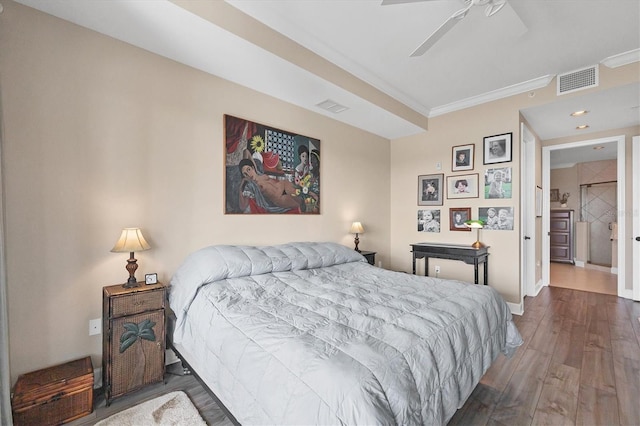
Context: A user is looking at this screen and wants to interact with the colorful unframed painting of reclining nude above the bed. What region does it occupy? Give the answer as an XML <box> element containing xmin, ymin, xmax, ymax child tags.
<box><xmin>224</xmin><ymin>115</ymin><xmax>320</xmax><ymax>214</ymax></box>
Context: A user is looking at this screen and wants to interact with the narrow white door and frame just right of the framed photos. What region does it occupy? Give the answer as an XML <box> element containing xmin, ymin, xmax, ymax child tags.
<box><xmin>520</xmin><ymin>123</ymin><xmax>542</xmax><ymax>302</ymax></box>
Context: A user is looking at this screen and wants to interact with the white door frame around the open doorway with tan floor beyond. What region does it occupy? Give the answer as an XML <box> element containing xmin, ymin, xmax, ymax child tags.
<box><xmin>542</xmin><ymin>135</ymin><xmax>632</xmax><ymax>299</ymax></box>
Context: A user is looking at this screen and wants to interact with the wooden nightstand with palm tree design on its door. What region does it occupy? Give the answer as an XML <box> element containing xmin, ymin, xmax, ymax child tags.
<box><xmin>102</xmin><ymin>283</ymin><xmax>166</xmax><ymax>406</ymax></box>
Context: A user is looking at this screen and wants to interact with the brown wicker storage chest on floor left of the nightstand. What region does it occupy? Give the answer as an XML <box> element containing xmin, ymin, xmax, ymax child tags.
<box><xmin>11</xmin><ymin>357</ymin><xmax>93</xmax><ymax>425</ymax></box>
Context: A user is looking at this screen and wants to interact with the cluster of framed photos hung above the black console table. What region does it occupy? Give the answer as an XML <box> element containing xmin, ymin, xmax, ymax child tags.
<box><xmin>417</xmin><ymin>133</ymin><xmax>515</xmax><ymax>233</ymax></box>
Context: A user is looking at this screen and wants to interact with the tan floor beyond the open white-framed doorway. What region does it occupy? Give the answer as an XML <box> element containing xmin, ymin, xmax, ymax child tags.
<box><xmin>549</xmin><ymin>262</ymin><xmax>618</xmax><ymax>296</ymax></box>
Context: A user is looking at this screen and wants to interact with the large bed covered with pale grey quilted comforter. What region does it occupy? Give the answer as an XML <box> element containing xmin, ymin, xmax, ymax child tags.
<box><xmin>169</xmin><ymin>242</ymin><xmax>522</xmax><ymax>425</ymax></box>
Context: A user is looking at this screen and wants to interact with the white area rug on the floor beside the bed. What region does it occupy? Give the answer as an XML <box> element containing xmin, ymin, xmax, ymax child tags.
<box><xmin>96</xmin><ymin>391</ymin><xmax>207</xmax><ymax>426</ymax></box>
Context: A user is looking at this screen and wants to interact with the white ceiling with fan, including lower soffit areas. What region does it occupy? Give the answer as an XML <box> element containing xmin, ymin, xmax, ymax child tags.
<box><xmin>12</xmin><ymin>0</ymin><xmax>640</xmax><ymax>148</ymax></box>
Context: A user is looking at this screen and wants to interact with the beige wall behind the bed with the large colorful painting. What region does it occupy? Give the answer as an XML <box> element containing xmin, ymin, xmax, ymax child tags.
<box><xmin>0</xmin><ymin>2</ymin><xmax>390</xmax><ymax>381</ymax></box>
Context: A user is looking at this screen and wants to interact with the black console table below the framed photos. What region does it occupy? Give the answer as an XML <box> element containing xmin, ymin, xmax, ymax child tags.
<box><xmin>411</xmin><ymin>243</ymin><xmax>489</xmax><ymax>285</ymax></box>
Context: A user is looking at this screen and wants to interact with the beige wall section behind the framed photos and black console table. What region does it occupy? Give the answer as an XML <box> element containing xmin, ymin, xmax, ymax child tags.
<box><xmin>391</xmin><ymin>96</ymin><xmax>520</xmax><ymax>303</ymax></box>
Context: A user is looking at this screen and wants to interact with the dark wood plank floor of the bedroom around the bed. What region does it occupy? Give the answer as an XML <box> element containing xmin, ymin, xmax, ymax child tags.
<box><xmin>73</xmin><ymin>287</ymin><xmax>640</xmax><ymax>426</ymax></box>
